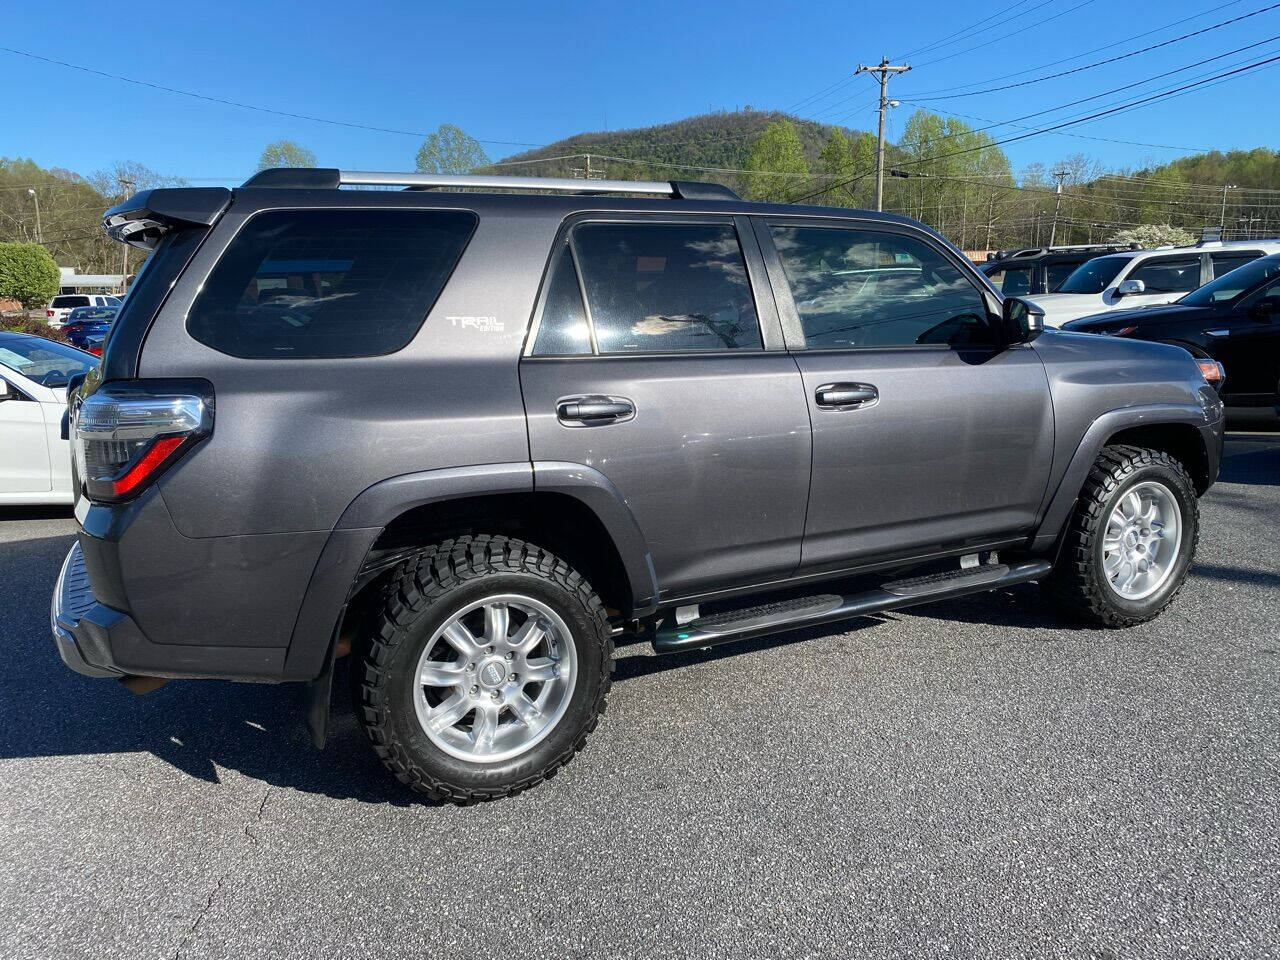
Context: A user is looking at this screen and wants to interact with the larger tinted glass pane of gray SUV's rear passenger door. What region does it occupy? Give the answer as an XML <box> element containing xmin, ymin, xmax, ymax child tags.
<box><xmin>571</xmin><ymin>223</ymin><xmax>760</xmax><ymax>353</ymax></box>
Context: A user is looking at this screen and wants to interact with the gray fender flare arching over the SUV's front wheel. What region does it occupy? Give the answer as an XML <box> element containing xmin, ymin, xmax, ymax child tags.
<box><xmin>1032</xmin><ymin>403</ymin><xmax>1222</xmax><ymax>552</ymax></box>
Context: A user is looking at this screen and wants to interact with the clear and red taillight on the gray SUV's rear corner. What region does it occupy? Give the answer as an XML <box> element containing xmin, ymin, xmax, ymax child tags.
<box><xmin>70</xmin><ymin>380</ymin><xmax>214</xmax><ymax>502</ymax></box>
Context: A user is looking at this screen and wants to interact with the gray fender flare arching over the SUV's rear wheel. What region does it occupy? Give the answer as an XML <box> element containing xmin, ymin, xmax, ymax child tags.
<box><xmin>282</xmin><ymin>461</ymin><xmax>658</xmax><ymax>681</ymax></box>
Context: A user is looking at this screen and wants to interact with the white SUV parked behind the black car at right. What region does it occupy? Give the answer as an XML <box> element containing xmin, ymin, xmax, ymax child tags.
<box><xmin>1032</xmin><ymin>241</ymin><xmax>1280</xmax><ymax>326</ymax></box>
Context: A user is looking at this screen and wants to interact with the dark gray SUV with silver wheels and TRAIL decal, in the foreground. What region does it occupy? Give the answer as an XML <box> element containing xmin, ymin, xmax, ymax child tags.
<box><xmin>52</xmin><ymin>169</ymin><xmax>1222</xmax><ymax>803</ymax></box>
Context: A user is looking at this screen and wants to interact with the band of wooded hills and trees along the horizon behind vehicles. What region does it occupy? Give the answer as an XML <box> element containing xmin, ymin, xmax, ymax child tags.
<box><xmin>0</xmin><ymin>108</ymin><xmax>1280</xmax><ymax>281</ymax></box>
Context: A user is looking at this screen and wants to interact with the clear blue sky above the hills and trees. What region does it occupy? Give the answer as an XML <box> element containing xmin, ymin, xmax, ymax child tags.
<box><xmin>0</xmin><ymin>0</ymin><xmax>1280</xmax><ymax>182</ymax></box>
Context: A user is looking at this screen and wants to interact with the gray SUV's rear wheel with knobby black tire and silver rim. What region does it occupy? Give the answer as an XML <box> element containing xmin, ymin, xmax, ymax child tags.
<box><xmin>356</xmin><ymin>536</ymin><xmax>613</xmax><ymax>803</ymax></box>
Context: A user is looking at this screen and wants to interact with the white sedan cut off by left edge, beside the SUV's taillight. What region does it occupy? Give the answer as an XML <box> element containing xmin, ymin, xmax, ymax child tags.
<box><xmin>0</xmin><ymin>332</ymin><xmax>97</xmax><ymax>504</ymax></box>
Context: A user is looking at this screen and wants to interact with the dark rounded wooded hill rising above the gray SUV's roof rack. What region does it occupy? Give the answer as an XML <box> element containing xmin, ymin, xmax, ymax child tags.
<box><xmin>490</xmin><ymin>108</ymin><xmax>880</xmax><ymax>186</ymax></box>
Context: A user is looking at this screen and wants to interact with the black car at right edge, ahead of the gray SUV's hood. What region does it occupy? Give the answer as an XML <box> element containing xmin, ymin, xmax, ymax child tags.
<box><xmin>1064</xmin><ymin>253</ymin><xmax>1280</xmax><ymax>426</ymax></box>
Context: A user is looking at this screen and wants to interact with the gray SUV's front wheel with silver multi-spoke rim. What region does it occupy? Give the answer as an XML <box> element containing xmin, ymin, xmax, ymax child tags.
<box><xmin>1048</xmin><ymin>445</ymin><xmax>1199</xmax><ymax>627</ymax></box>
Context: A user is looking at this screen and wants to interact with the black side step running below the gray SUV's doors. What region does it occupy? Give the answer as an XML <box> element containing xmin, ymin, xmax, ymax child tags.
<box><xmin>653</xmin><ymin>559</ymin><xmax>1053</xmax><ymax>653</ymax></box>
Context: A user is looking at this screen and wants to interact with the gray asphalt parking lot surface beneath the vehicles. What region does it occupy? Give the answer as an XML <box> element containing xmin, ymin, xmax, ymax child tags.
<box><xmin>0</xmin><ymin>435</ymin><xmax>1280</xmax><ymax>960</ymax></box>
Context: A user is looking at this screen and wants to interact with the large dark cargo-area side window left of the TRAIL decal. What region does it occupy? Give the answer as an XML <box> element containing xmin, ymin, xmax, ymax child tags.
<box><xmin>187</xmin><ymin>210</ymin><xmax>476</xmax><ymax>360</ymax></box>
